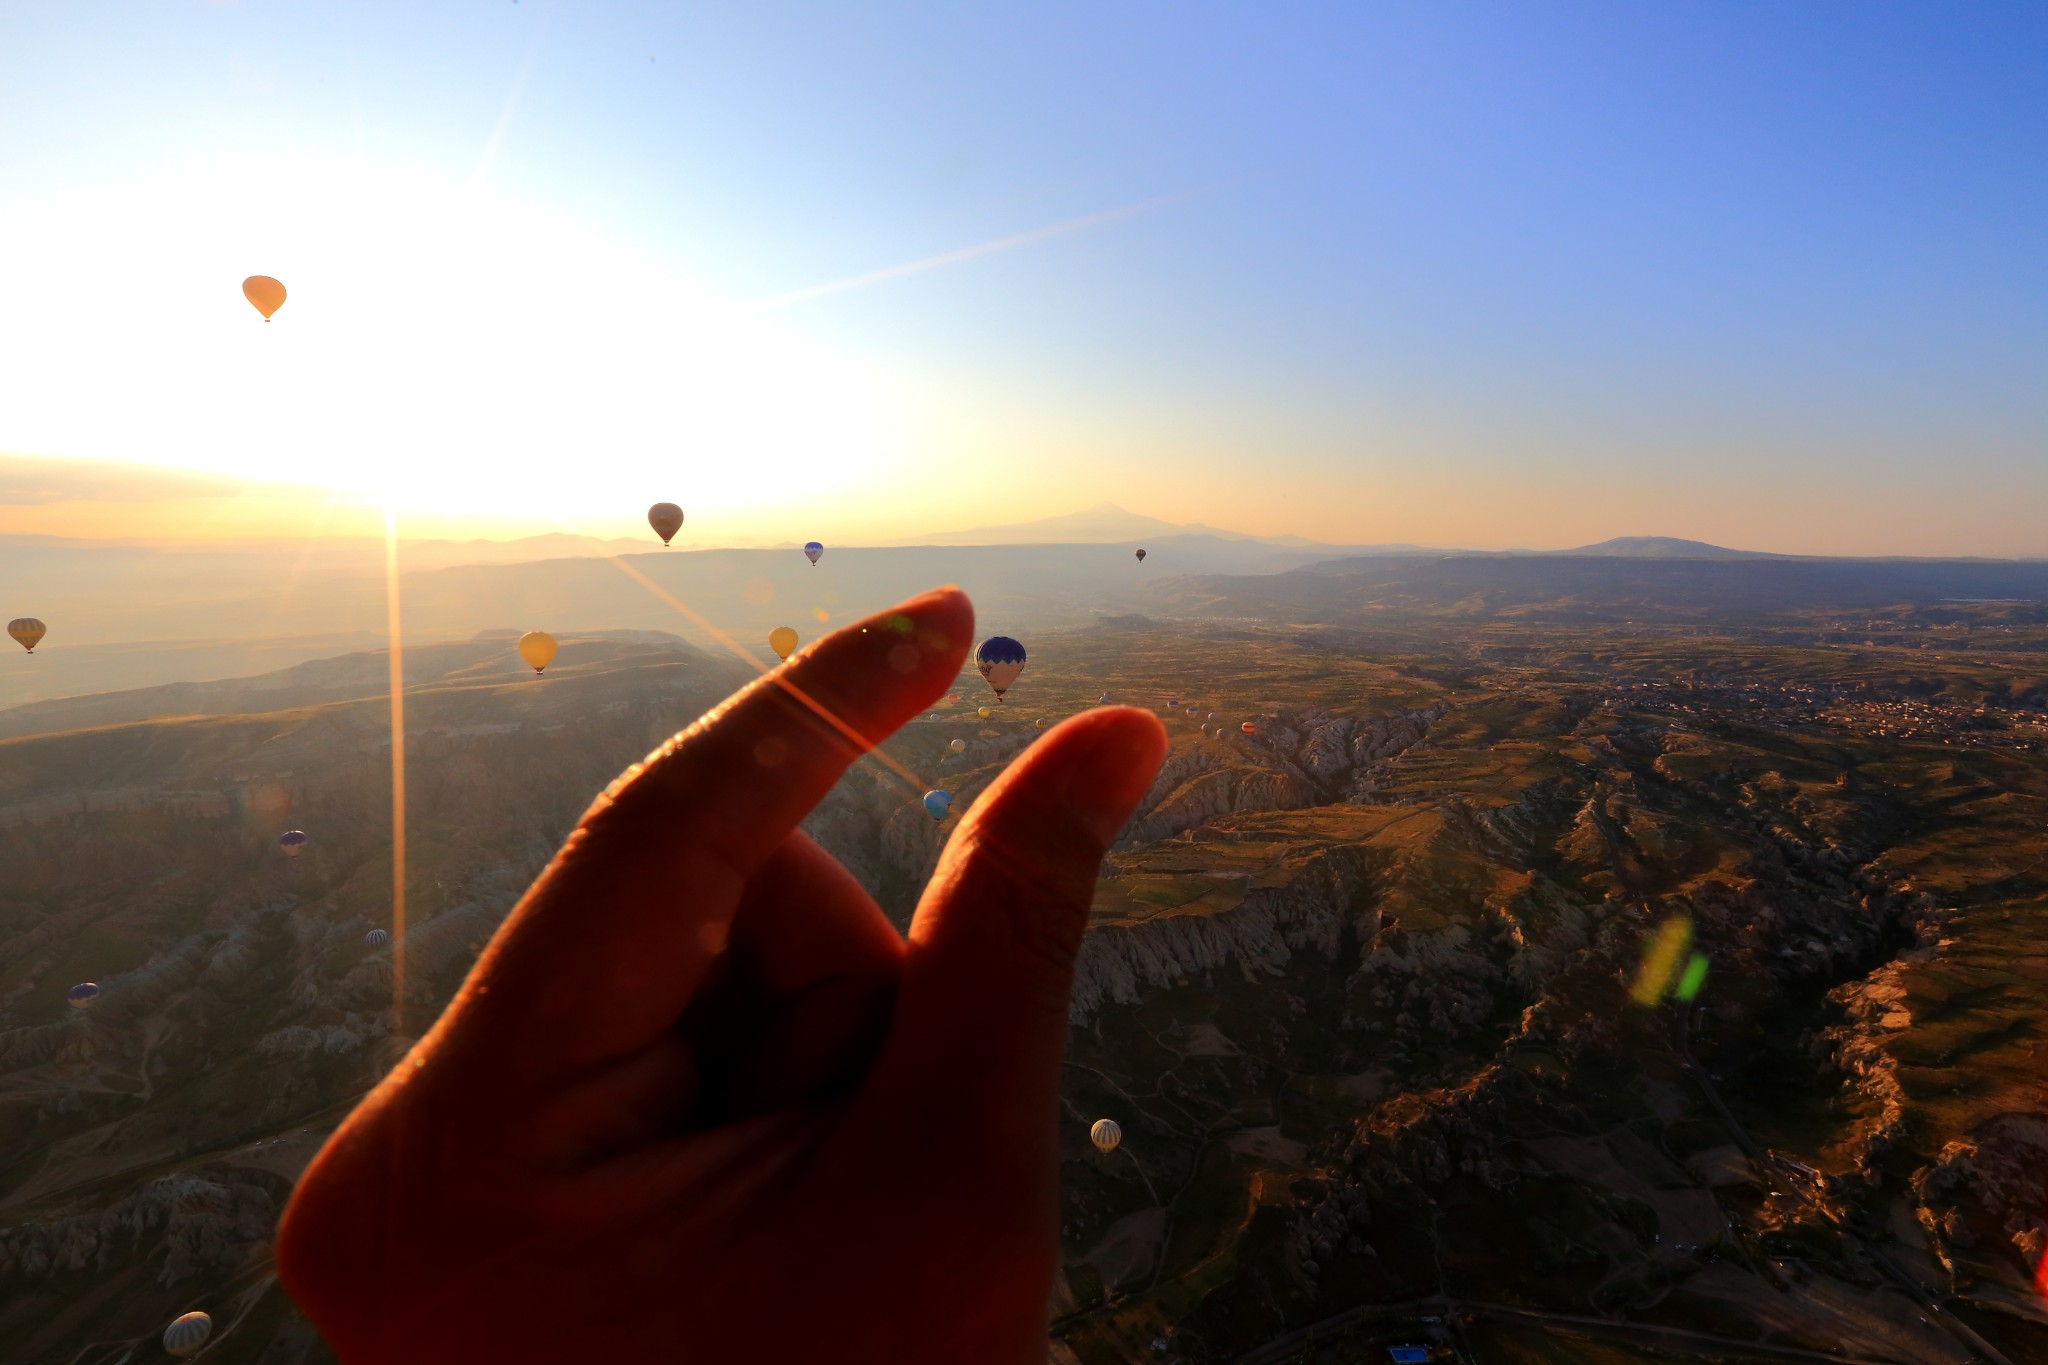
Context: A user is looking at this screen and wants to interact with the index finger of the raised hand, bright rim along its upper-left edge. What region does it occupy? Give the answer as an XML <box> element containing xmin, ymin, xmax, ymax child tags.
<box><xmin>436</xmin><ymin>587</ymin><xmax>975</xmax><ymax>1081</ymax></box>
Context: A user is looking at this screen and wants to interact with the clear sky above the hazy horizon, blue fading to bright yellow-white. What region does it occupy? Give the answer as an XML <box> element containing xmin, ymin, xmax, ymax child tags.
<box><xmin>0</xmin><ymin>0</ymin><xmax>2048</xmax><ymax>555</ymax></box>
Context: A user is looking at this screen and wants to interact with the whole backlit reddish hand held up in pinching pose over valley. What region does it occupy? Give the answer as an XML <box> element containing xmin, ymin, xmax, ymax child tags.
<box><xmin>276</xmin><ymin>589</ymin><xmax>1165</xmax><ymax>1365</ymax></box>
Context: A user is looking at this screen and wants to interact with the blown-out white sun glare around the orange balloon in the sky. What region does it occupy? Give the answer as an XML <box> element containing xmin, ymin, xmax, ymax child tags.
<box><xmin>0</xmin><ymin>162</ymin><xmax>897</xmax><ymax>540</ymax></box>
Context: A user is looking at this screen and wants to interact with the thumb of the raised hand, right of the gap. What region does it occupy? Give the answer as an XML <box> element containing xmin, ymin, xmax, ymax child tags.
<box><xmin>856</xmin><ymin>706</ymin><xmax>1167</xmax><ymax>1185</ymax></box>
